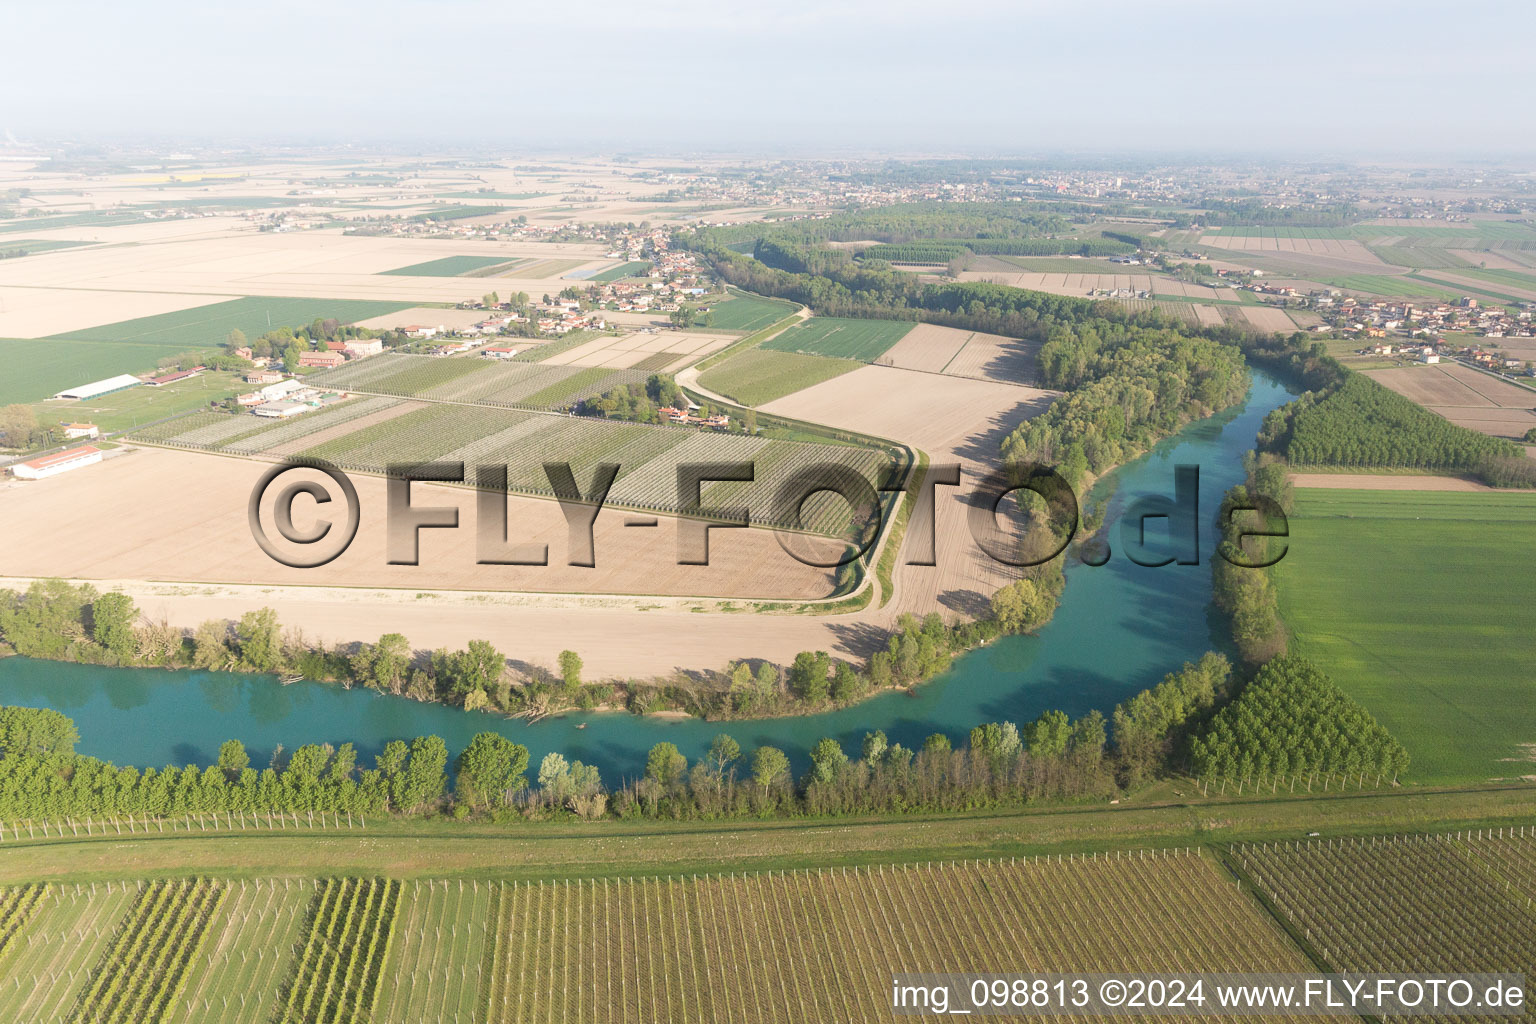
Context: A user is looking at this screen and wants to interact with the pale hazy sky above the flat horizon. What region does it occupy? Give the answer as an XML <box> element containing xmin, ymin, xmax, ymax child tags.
<box><xmin>12</xmin><ymin>0</ymin><xmax>1536</xmax><ymax>158</ymax></box>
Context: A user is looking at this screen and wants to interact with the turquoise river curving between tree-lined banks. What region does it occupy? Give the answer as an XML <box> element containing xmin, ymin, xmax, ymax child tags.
<box><xmin>0</xmin><ymin>372</ymin><xmax>1290</xmax><ymax>785</ymax></box>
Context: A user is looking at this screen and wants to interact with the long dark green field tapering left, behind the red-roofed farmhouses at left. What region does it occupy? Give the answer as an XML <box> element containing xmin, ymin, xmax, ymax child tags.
<box><xmin>55</xmin><ymin>296</ymin><xmax>410</xmax><ymax>348</ymax></box>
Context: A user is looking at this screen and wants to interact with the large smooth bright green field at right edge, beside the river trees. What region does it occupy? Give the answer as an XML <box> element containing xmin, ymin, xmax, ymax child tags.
<box><xmin>1276</xmin><ymin>490</ymin><xmax>1536</xmax><ymax>783</ymax></box>
